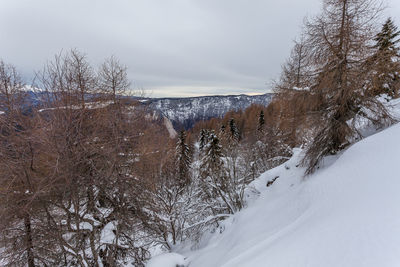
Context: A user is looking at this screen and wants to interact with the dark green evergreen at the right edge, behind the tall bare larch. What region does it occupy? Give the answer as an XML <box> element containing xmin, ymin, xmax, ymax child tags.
<box><xmin>370</xmin><ymin>18</ymin><xmax>400</xmax><ymax>96</ymax></box>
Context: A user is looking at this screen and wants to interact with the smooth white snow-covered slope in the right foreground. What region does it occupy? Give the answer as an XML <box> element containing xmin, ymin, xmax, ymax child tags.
<box><xmin>182</xmin><ymin>124</ymin><xmax>400</xmax><ymax>267</ymax></box>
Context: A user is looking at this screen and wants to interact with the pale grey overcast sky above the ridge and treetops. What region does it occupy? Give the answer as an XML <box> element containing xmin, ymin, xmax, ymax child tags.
<box><xmin>0</xmin><ymin>0</ymin><xmax>400</xmax><ymax>97</ymax></box>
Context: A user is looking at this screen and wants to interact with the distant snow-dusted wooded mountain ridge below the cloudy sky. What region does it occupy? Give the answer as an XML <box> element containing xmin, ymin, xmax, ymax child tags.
<box><xmin>143</xmin><ymin>94</ymin><xmax>273</xmax><ymax>129</ymax></box>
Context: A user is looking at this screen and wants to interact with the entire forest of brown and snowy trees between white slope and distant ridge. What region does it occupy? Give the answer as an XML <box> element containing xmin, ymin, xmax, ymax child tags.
<box><xmin>0</xmin><ymin>0</ymin><xmax>400</xmax><ymax>267</ymax></box>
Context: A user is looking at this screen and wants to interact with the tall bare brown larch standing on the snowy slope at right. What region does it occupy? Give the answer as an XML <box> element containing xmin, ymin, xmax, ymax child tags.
<box><xmin>304</xmin><ymin>0</ymin><xmax>390</xmax><ymax>173</ymax></box>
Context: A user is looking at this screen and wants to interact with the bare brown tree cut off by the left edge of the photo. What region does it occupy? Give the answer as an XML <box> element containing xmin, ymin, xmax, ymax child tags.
<box><xmin>0</xmin><ymin>59</ymin><xmax>59</xmax><ymax>267</ymax></box>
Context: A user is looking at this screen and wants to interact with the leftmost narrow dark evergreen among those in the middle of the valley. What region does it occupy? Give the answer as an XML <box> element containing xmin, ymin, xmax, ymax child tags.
<box><xmin>176</xmin><ymin>130</ymin><xmax>192</xmax><ymax>187</ymax></box>
